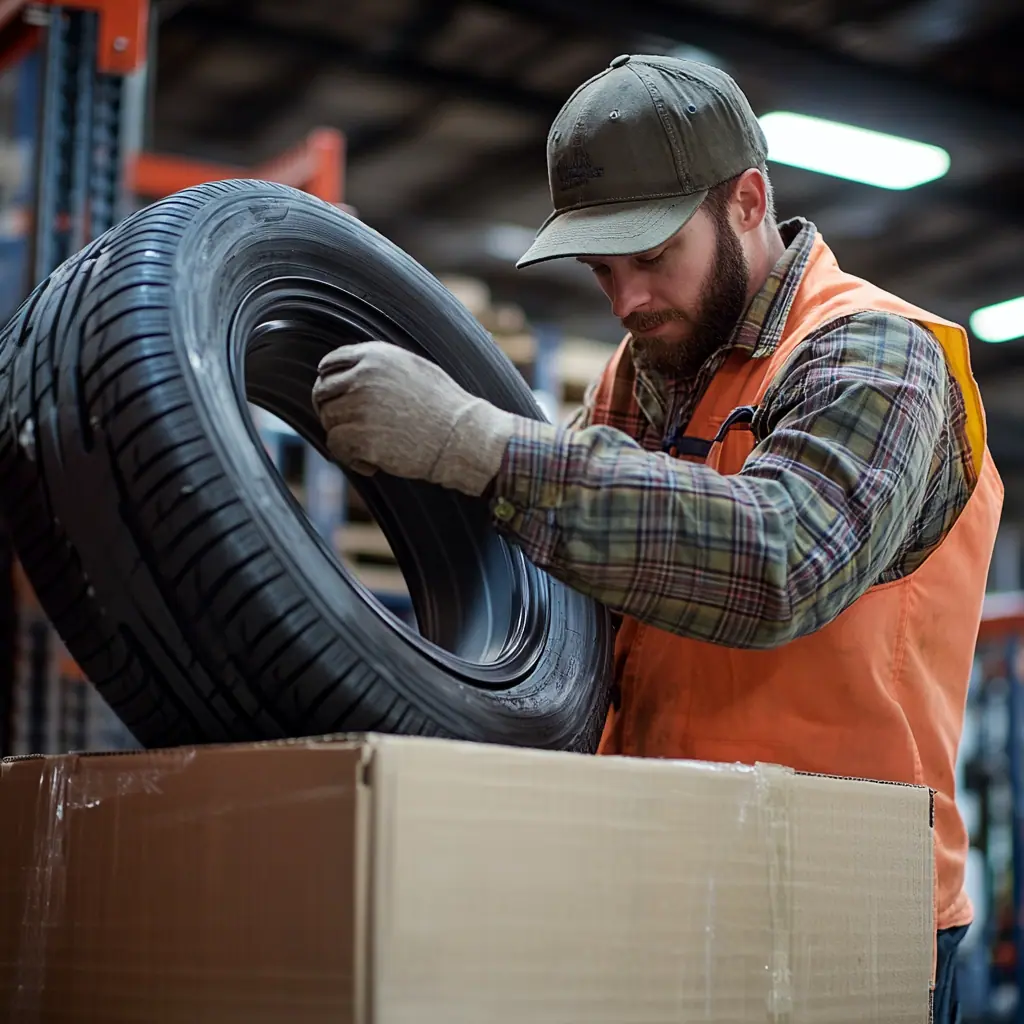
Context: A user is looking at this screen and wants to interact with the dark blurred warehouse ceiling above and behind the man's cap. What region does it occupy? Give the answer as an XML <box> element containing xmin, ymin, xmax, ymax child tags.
<box><xmin>148</xmin><ymin>0</ymin><xmax>1024</xmax><ymax>518</ymax></box>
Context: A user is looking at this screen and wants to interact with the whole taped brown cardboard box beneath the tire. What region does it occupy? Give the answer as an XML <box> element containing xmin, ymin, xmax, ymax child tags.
<box><xmin>0</xmin><ymin>736</ymin><xmax>934</xmax><ymax>1024</ymax></box>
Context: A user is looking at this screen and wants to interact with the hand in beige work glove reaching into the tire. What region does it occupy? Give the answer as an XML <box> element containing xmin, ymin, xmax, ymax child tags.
<box><xmin>312</xmin><ymin>341</ymin><xmax>518</xmax><ymax>497</ymax></box>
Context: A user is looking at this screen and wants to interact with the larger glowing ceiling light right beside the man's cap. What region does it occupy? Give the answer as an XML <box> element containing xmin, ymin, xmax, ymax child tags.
<box><xmin>760</xmin><ymin>111</ymin><xmax>949</xmax><ymax>188</ymax></box>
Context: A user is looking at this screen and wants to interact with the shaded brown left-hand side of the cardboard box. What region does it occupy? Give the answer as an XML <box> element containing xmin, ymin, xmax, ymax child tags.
<box><xmin>0</xmin><ymin>742</ymin><xmax>369</xmax><ymax>1024</ymax></box>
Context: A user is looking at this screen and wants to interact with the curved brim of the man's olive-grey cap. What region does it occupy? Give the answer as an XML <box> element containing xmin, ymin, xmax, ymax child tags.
<box><xmin>516</xmin><ymin>189</ymin><xmax>708</xmax><ymax>269</ymax></box>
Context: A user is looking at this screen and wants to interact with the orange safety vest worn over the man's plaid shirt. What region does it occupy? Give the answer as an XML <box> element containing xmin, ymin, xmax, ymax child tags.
<box><xmin>592</xmin><ymin>236</ymin><xmax>1002</xmax><ymax>929</ymax></box>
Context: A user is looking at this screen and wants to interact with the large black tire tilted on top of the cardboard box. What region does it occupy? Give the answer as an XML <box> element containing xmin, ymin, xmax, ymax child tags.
<box><xmin>0</xmin><ymin>181</ymin><xmax>611</xmax><ymax>751</ymax></box>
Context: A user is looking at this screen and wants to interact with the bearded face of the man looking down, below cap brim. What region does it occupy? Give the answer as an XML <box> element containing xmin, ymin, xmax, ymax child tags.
<box><xmin>581</xmin><ymin>201</ymin><xmax>750</xmax><ymax>377</ymax></box>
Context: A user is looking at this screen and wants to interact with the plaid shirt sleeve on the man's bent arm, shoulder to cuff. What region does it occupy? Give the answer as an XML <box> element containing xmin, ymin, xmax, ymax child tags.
<box><xmin>493</xmin><ymin>313</ymin><xmax>946</xmax><ymax>648</ymax></box>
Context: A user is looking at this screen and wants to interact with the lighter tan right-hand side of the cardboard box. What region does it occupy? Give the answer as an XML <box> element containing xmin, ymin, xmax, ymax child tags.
<box><xmin>370</xmin><ymin>737</ymin><xmax>932</xmax><ymax>1024</ymax></box>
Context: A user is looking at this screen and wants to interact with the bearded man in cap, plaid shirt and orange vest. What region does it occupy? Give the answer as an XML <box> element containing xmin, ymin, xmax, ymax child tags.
<box><xmin>314</xmin><ymin>55</ymin><xmax>1002</xmax><ymax>1021</ymax></box>
